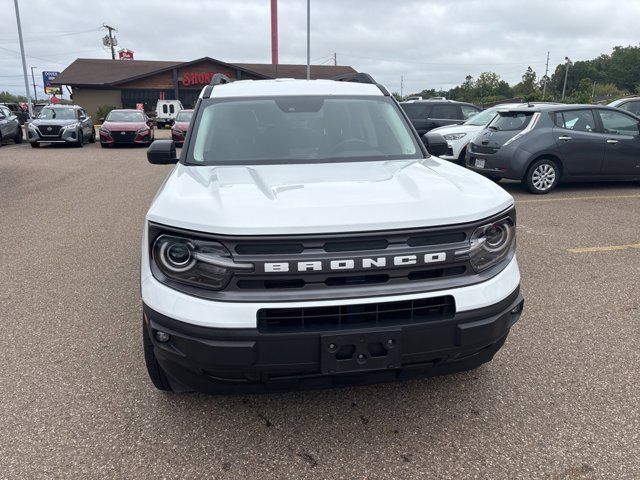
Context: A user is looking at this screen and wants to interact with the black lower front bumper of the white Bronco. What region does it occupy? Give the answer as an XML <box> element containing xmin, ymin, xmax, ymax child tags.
<box><xmin>144</xmin><ymin>288</ymin><xmax>524</xmax><ymax>393</ymax></box>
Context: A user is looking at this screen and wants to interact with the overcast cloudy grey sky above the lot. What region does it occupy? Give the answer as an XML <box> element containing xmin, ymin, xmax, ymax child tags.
<box><xmin>0</xmin><ymin>0</ymin><xmax>640</xmax><ymax>98</ymax></box>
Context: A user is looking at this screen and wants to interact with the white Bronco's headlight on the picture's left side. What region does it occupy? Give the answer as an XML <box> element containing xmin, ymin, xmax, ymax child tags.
<box><xmin>152</xmin><ymin>235</ymin><xmax>253</xmax><ymax>290</ymax></box>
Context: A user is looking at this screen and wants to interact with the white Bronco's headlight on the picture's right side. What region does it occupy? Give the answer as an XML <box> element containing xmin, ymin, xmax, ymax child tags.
<box><xmin>455</xmin><ymin>217</ymin><xmax>516</xmax><ymax>273</ymax></box>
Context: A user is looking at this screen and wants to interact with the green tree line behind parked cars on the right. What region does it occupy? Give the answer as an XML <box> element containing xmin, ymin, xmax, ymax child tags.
<box><xmin>402</xmin><ymin>46</ymin><xmax>640</xmax><ymax>105</ymax></box>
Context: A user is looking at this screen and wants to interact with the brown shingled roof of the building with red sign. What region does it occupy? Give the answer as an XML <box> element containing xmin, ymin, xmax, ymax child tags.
<box><xmin>51</xmin><ymin>57</ymin><xmax>356</xmax><ymax>87</ymax></box>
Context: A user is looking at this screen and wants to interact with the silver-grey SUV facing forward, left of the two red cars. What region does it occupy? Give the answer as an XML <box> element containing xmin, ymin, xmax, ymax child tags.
<box><xmin>27</xmin><ymin>105</ymin><xmax>96</xmax><ymax>148</ymax></box>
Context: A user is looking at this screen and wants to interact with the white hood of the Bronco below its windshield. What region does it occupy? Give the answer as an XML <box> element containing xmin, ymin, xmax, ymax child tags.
<box><xmin>147</xmin><ymin>157</ymin><xmax>513</xmax><ymax>235</ymax></box>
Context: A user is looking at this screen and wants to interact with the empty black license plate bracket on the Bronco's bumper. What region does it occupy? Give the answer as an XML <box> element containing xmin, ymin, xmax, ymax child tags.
<box><xmin>320</xmin><ymin>330</ymin><xmax>402</xmax><ymax>375</ymax></box>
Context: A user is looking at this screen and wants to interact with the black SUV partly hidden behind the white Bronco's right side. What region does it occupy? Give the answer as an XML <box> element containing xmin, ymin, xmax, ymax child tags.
<box><xmin>400</xmin><ymin>100</ymin><xmax>482</xmax><ymax>135</ymax></box>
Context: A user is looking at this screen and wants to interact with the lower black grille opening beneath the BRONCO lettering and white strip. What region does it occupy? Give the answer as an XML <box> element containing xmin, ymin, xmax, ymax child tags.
<box><xmin>257</xmin><ymin>295</ymin><xmax>456</xmax><ymax>333</ymax></box>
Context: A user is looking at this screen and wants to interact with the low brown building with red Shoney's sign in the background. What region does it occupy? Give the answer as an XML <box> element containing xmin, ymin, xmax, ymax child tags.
<box><xmin>51</xmin><ymin>57</ymin><xmax>355</xmax><ymax>117</ymax></box>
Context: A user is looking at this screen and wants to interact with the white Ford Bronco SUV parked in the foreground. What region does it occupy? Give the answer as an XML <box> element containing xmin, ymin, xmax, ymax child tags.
<box><xmin>141</xmin><ymin>74</ymin><xmax>523</xmax><ymax>393</ymax></box>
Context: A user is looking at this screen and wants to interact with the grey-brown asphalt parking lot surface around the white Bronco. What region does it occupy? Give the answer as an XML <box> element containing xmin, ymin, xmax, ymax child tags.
<box><xmin>0</xmin><ymin>131</ymin><xmax>640</xmax><ymax>479</ymax></box>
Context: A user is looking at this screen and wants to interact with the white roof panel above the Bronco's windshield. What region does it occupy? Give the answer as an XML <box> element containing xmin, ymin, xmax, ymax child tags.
<box><xmin>211</xmin><ymin>78</ymin><xmax>383</xmax><ymax>98</ymax></box>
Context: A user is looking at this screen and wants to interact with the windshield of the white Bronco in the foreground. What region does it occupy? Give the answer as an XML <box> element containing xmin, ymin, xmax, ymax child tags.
<box><xmin>193</xmin><ymin>96</ymin><xmax>422</xmax><ymax>164</ymax></box>
